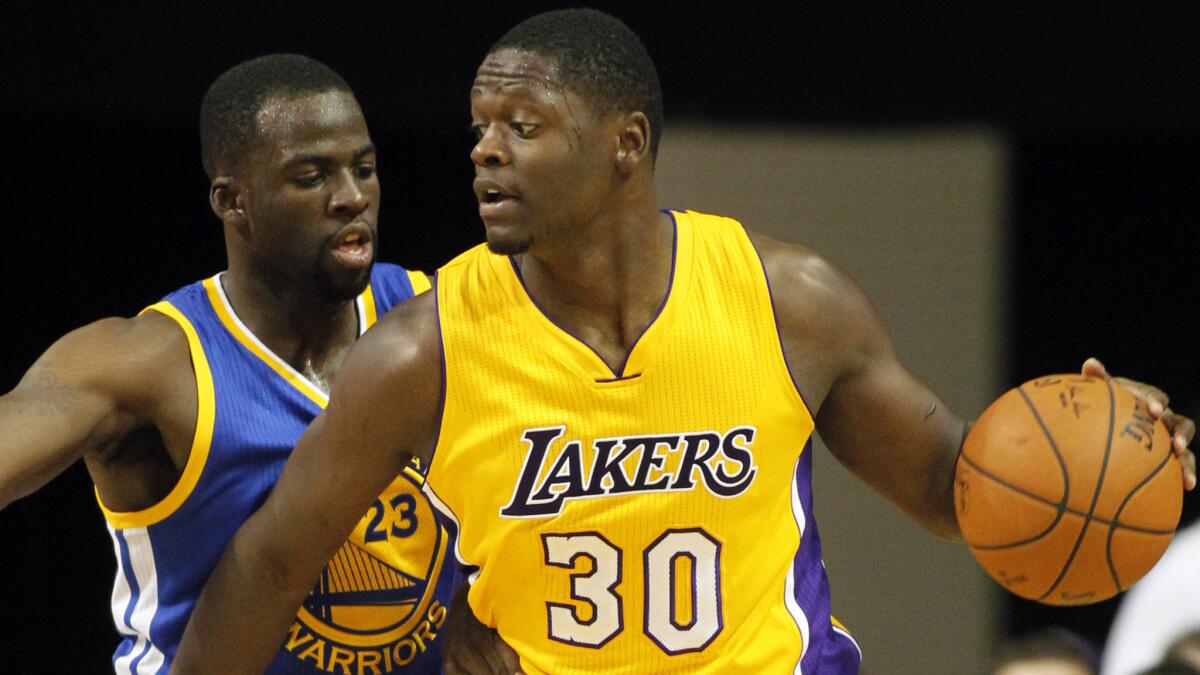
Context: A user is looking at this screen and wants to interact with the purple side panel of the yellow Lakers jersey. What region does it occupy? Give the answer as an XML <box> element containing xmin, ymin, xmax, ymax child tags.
<box><xmin>792</xmin><ymin>438</ymin><xmax>860</xmax><ymax>675</ymax></box>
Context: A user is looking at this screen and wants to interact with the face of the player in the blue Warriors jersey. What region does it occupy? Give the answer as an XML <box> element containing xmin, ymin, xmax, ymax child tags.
<box><xmin>242</xmin><ymin>91</ymin><xmax>379</xmax><ymax>300</ymax></box>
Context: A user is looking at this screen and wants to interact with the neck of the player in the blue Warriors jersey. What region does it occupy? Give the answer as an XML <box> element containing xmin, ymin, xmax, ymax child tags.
<box><xmin>221</xmin><ymin>256</ymin><xmax>358</xmax><ymax>379</ymax></box>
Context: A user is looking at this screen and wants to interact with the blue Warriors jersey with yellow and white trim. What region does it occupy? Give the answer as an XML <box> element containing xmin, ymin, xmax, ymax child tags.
<box><xmin>97</xmin><ymin>263</ymin><xmax>456</xmax><ymax>675</ymax></box>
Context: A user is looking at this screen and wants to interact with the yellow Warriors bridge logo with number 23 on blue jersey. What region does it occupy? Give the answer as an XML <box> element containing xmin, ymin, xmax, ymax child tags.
<box><xmin>283</xmin><ymin>458</ymin><xmax>448</xmax><ymax>673</ymax></box>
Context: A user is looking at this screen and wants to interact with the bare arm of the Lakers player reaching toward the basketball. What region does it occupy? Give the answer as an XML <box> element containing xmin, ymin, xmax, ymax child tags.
<box><xmin>754</xmin><ymin>235</ymin><xmax>965</xmax><ymax>538</ymax></box>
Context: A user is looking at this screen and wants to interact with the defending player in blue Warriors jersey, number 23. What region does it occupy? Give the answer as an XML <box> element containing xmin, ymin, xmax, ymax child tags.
<box><xmin>0</xmin><ymin>54</ymin><xmax>455</xmax><ymax>674</ymax></box>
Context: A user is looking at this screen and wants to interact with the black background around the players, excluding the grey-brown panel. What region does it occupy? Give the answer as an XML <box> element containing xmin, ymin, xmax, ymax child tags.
<box><xmin>0</xmin><ymin>1</ymin><xmax>1200</xmax><ymax>673</ymax></box>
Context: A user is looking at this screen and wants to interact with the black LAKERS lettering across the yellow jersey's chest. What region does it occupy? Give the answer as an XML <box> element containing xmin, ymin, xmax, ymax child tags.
<box><xmin>500</xmin><ymin>426</ymin><xmax>758</xmax><ymax>518</ymax></box>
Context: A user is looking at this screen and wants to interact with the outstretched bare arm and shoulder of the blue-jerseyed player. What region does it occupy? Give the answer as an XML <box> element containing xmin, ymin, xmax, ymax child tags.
<box><xmin>0</xmin><ymin>305</ymin><xmax>197</xmax><ymax>510</ymax></box>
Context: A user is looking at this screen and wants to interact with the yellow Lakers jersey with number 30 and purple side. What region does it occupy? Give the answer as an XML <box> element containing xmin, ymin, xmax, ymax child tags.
<box><xmin>426</xmin><ymin>211</ymin><xmax>858</xmax><ymax>674</ymax></box>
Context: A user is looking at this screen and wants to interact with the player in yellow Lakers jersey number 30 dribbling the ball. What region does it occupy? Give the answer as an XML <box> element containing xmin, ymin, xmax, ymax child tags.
<box><xmin>176</xmin><ymin>10</ymin><xmax>1195</xmax><ymax>675</ymax></box>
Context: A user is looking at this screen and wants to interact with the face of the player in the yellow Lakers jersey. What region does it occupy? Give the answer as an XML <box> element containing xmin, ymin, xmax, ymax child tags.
<box><xmin>470</xmin><ymin>49</ymin><xmax>619</xmax><ymax>253</ymax></box>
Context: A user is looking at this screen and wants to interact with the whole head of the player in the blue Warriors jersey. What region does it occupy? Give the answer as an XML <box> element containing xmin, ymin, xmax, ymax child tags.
<box><xmin>200</xmin><ymin>54</ymin><xmax>379</xmax><ymax>300</ymax></box>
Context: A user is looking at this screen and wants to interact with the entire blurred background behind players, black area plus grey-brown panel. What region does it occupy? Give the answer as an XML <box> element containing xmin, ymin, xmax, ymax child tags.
<box><xmin>0</xmin><ymin>1</ymin><xmax>1200</xmax><ymax>674</ymax></box>
